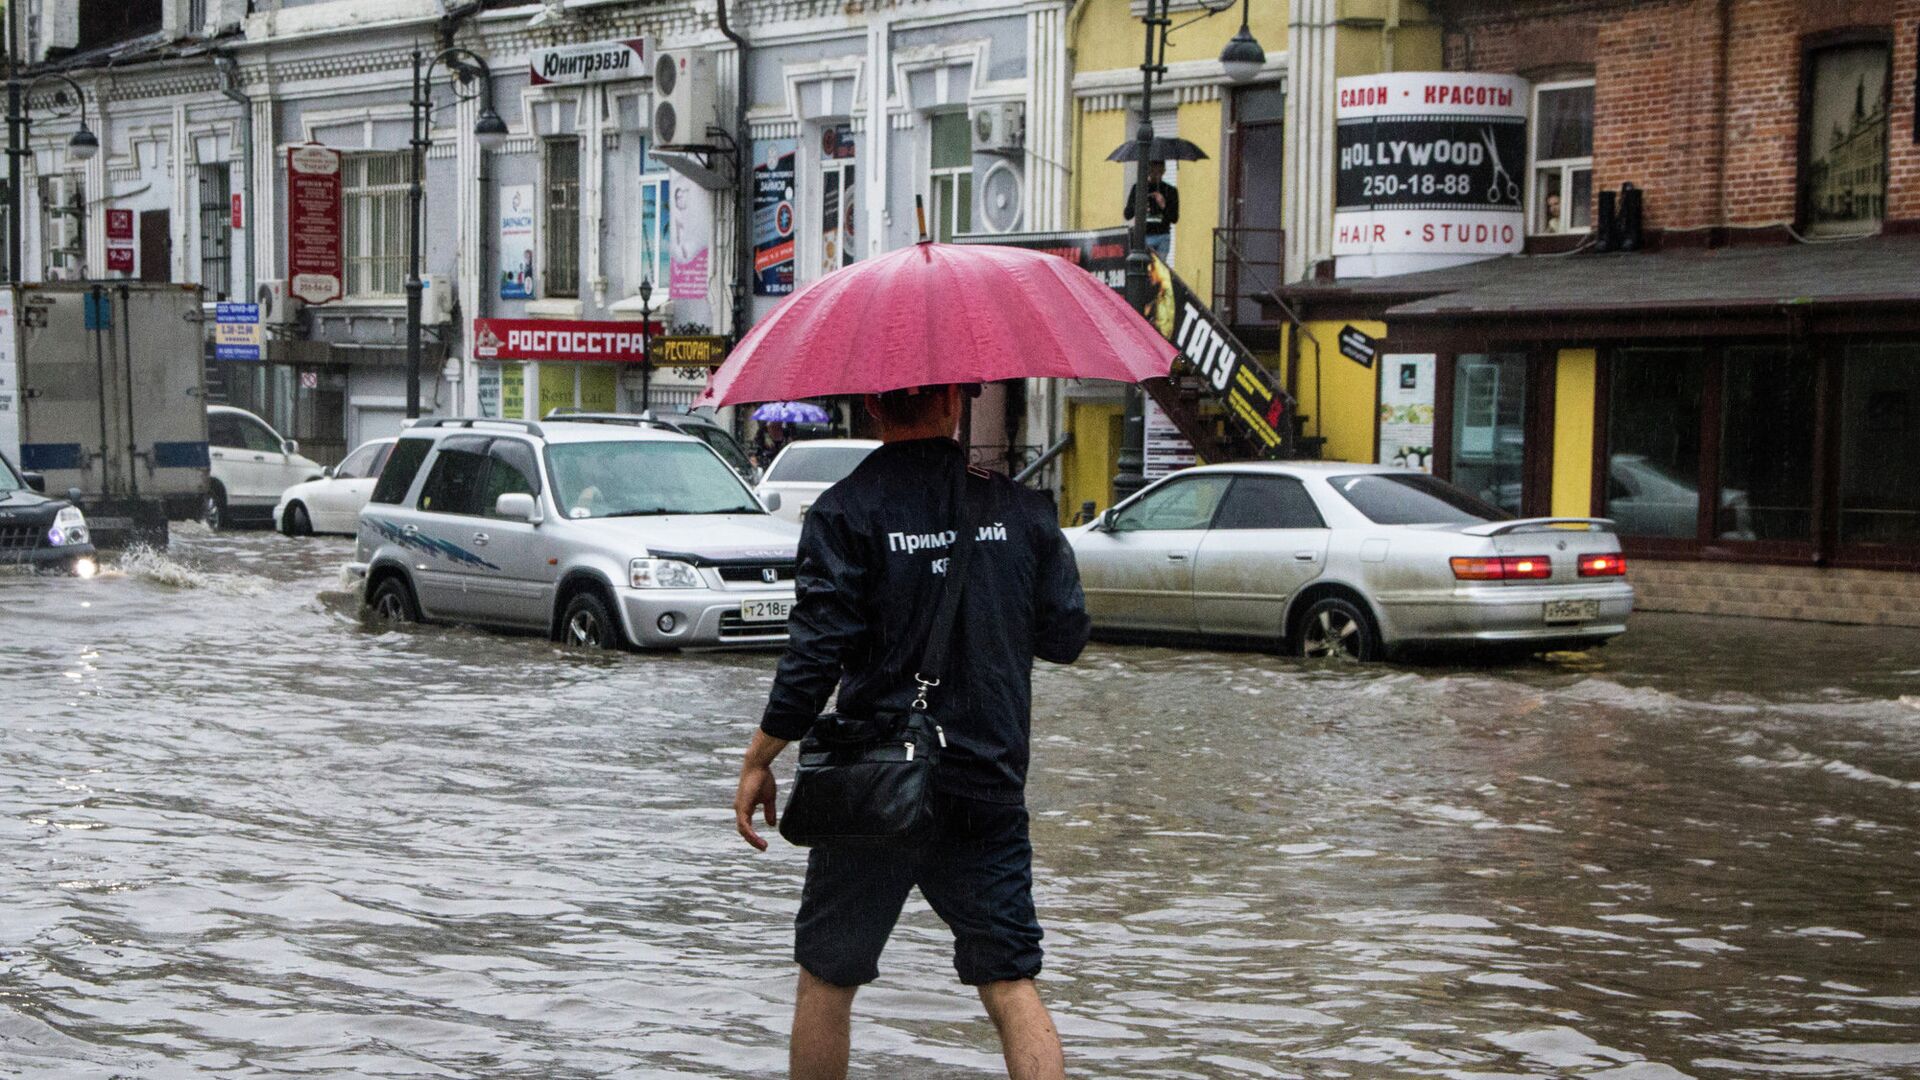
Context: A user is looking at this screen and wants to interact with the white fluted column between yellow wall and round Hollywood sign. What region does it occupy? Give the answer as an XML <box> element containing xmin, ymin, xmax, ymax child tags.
<box><xmin>1281</xmin><ymin>0</ymin><xmax>1338</xmax><ymax>281</ymax></box>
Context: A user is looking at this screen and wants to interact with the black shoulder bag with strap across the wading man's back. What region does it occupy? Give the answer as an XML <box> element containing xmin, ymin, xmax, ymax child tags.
<box><xmin>780</xmin><ymin>461</ymin><xmax>973</xmax><ymax>849</ymax></box>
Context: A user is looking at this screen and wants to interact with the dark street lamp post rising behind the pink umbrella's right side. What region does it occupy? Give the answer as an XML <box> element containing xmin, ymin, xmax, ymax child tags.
<box><xmin>1114</xmin><ymin>0</ymin><xmax>1267</xmax><ymax>502</ymax></box>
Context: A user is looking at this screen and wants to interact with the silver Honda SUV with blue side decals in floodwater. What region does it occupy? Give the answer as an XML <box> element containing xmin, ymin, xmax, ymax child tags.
<box><xmin>349</xmin><ymin>419</ymin><xmax>801</xmax><ymax>648</ymax></box>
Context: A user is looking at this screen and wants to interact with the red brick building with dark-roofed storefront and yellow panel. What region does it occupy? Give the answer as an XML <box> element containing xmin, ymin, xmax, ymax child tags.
<box><xmin>1283</xmin><ymin>0</ymin><xmax>1920</xmax><ymax>625</ymax></box>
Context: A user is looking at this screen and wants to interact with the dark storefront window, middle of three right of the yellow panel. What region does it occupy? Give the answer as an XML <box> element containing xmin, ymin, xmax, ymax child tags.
<box><xmin>1715</xmin><ymin>346</ymin><xmax>1818</xmax><ymax>542</ymax></box>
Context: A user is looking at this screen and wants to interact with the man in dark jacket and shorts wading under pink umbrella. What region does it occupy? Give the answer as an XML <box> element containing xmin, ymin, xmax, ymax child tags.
<box><xmin>733</xmin><ymin>386</ymin><xmax>1091</xmax><ymax>1080</ymax></box>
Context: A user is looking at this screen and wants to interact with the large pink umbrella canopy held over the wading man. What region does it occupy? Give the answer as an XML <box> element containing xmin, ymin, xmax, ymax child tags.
<box><xmin>699</xmin><ymin>242</ymin><xmax>1175</xmax><ymax>405</ymax></box>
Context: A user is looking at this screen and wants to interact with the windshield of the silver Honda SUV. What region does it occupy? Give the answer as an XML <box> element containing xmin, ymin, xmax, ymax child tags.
<box><xmin>547</xmin><ymin>440</ymin><xmax>766</xmax><ymax>517</ymax></box>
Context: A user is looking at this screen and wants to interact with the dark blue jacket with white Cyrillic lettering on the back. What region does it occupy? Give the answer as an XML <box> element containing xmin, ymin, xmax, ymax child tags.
<box><xmin>760</xmin><ymin>438</ymin><xmax>1091</xmax><ymax>801</ymax></box>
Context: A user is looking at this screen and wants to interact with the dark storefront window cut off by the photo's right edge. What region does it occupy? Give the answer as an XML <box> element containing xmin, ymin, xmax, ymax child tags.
<box><xmin>1839</xmin><ymin>342</ymin><xmax>1920</xmax><ymax>546</ymax></box>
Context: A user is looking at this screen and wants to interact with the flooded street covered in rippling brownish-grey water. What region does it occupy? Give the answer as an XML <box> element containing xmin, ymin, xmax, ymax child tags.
<box><xmin>0</xmin><ymin>532</ymin><xmax>1920</xmax><ymax>1080</ymax></box>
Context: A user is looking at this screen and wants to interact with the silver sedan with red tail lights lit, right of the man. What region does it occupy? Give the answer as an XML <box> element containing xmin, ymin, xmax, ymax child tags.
<box><xmin>1068</xmin><ymin>461</ymin><xmax>1634</xmax><ymax>659</ymax></box>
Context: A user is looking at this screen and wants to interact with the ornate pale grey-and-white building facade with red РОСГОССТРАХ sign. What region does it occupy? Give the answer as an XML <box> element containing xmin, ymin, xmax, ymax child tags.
<box><xmin>15</xmin><ymin>0</ymin><xmax>1068</xmax><ymax>461</ymax></box>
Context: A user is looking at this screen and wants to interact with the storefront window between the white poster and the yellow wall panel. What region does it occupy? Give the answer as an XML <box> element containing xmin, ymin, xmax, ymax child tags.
<box><xmin>1452</xmin><ymin>352</ymin><xmax>1526</xmax><ymax>513</ymax></box>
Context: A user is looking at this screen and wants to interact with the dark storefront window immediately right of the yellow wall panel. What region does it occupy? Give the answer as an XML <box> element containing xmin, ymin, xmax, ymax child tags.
<box><xmin>1607</xmin><ymin>348</ymin><xmax>1705</xmax><ymax>538</ymax></box>
